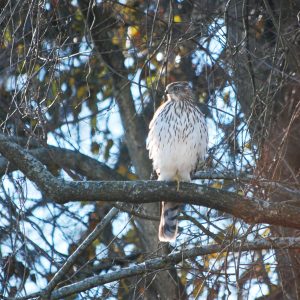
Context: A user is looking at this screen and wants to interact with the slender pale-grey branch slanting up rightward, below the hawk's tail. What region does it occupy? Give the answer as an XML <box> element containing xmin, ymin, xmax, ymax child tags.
<box><xmin>7</xmin><ymin>238</ymin><xmax>300</xmax><ymax>300</ymax></box>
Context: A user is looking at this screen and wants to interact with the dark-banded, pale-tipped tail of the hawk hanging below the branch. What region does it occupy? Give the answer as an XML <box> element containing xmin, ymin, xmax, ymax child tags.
<box><xmin>158</xmin><ymin>202</ymin><xmax>180</xmax><ymax>242</ymax></box>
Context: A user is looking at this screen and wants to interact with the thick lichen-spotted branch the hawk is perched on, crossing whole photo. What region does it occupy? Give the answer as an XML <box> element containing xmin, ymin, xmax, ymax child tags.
<box><xmin>0</xmin><ymin>134</ymin><xmax>300</xmax><ymax>228</ymax></box>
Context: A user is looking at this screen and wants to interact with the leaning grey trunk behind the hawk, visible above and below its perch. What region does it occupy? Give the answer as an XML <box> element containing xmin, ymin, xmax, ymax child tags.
<box><xmin>79</xmin><ymin>0</ymin><xmax>183</xmax><ymax>300</ymax></box>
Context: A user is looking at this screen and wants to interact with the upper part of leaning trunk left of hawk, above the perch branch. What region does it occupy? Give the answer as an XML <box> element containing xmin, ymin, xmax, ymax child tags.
<box><xmin>78</xmin><ymin>0</ymin><xmax>152</xmax><ymax>179</ymax></box>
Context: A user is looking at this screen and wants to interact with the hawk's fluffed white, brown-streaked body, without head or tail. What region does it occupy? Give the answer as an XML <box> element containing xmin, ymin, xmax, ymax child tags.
<box><xmin>147</xmin><ymin>100</ymin><xmax>208</xmax><ymax>181</ymax></box>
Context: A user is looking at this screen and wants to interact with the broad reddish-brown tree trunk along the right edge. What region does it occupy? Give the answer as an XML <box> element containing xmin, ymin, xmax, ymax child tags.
<box><xmin>227</xmin><ymin>0</ymin><xmax>300</xmax><ymax>299</ymax></box>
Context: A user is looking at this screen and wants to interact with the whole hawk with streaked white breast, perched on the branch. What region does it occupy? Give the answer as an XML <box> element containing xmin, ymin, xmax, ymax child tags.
<box><xmin>147</xmin><ymin>81</ymin><xmax>208</xmax><ymax>242</ymax></box>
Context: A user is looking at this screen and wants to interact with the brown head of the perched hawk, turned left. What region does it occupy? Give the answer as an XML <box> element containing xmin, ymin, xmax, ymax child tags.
<box><xmin>165</xmin><ymin>81</ymin><xmax>194</xmax><ymax>101</ymax></box>
